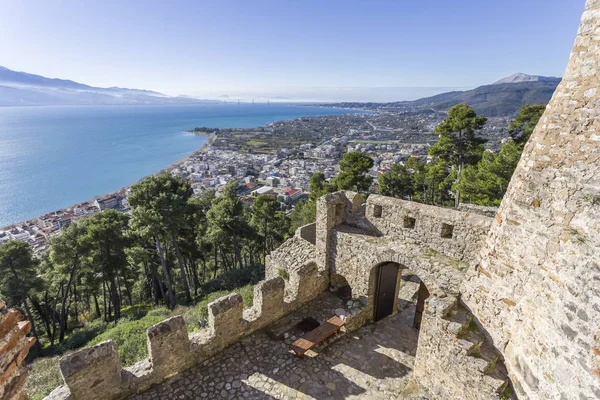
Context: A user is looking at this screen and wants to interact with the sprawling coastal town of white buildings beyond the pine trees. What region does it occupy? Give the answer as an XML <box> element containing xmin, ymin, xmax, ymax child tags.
<box><xmin>0</xmin><ymin>110</ymin><xmax>509</xmax><ymax>253</ymax></box>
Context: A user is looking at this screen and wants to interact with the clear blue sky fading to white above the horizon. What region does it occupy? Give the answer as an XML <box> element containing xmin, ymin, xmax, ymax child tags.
<box><xmin>0</xmin><ymin>0</ymin><xmax>585</xmax><ymax>97</ymax></box>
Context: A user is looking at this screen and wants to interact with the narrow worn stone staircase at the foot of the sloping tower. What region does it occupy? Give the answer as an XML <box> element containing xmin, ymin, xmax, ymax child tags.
<box><xmin>444</xmin><ymin>302</ymin><xmax>516</xmax><ymax>400</ymax></box>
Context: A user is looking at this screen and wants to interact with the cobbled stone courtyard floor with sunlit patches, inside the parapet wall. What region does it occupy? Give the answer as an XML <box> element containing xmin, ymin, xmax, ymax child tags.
<box><xmin>132</xmin><ymin>293</ymin><xmax>422</xmax><ymax>400</ymax></box>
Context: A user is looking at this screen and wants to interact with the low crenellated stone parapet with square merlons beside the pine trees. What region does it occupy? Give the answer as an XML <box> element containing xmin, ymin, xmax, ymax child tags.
<box><xmin>49</xmin><ymin>262</ymin><xmax>328</xmax><ymax>400</ymax></box>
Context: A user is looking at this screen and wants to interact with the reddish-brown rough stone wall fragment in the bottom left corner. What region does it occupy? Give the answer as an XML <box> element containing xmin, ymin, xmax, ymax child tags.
<box><xmin>0</xmin><ymin>300</ymin><xmax>35</xmax><ymax>400</ymax></box>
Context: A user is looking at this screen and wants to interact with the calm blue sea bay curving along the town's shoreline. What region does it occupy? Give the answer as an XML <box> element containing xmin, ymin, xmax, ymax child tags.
<box><xmin>0</xmin><ymin>103</ymin><xmax>356</xmax><ymax>227</ymax></box>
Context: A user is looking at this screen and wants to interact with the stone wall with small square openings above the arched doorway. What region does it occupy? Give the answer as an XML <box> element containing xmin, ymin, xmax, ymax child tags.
<box><xmin>324</xmin><ymin>192</ymin><xmax>492</xmax><ymax>303</ymax></box>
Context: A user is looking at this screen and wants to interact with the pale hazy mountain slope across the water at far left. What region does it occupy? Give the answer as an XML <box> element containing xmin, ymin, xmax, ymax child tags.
<box><xmin>0</xmin><ymin>66</ymin><xmax>213</xmax><ymax>106</ymax></box>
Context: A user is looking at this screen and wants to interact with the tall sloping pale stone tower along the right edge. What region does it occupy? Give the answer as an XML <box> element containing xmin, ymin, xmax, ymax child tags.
<box><xmin>462</xmin><ymin>0</ymin><xmax>600</xmax><ymax>399</ymax></box>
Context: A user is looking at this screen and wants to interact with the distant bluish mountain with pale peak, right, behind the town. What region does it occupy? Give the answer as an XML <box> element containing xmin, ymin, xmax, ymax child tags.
<box><xmin>324</xmin><ymin>74</ymin><xmax>561</xmax><ymax>117</ymax></box>
